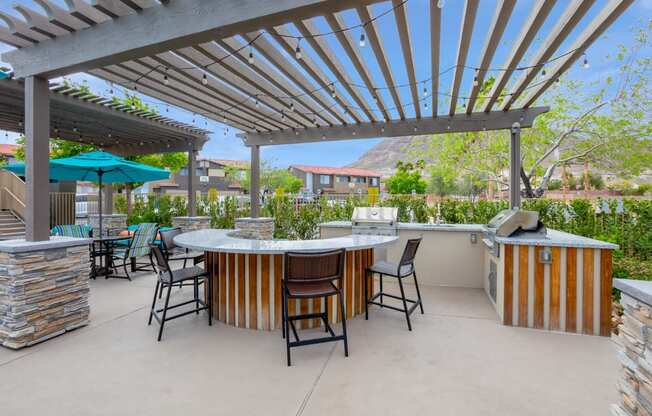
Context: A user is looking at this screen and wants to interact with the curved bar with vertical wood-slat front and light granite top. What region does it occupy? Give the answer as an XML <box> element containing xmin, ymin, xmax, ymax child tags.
<box><xmin>174</xmin><ymin>229</ymin><xmax>398</xmax><ymax>330</ymax></box>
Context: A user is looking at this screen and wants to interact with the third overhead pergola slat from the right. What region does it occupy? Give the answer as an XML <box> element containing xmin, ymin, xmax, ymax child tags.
<box><xmin>482</xmin><ymin>0</ymin><xmax>557</xmax><ymax>113</ymax></box>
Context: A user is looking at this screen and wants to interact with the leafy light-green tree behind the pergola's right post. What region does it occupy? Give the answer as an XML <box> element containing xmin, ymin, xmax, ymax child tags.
<box><xmin>416</xmin><ymin>24</ymin><xmax>652</xmax><ymax>198</ymax></box>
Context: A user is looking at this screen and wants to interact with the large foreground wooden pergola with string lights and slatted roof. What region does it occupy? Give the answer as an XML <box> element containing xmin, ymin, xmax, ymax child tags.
<box><xmin>0</xmin><ymin>0</ymin><xmax>633</xmax><ymax>239</ymax></box>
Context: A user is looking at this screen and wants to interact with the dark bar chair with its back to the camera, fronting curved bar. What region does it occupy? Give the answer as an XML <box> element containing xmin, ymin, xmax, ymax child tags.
<box><xmin>282</xmin><ymin>249</ymin><xmax>349</xmax><ymax>367</ymax></box>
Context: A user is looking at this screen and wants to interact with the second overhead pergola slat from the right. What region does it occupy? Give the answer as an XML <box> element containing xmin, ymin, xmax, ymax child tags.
<box><xmin>502</xmin><ymin>0</ymin><xmax>595</xmax><ymax>110</ymax></box>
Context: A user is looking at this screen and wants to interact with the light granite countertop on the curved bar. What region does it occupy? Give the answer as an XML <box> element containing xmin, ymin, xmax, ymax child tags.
<box><xmin>174</xmin><ymin>229</ymin><xmax>398</xmax><ymax>254</ymax></box>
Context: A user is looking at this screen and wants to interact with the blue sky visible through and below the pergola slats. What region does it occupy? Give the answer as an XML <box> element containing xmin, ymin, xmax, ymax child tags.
<box><xmin>0</xmin><ymin>0</ymin><xmax>652</xmax><ymax>166</ymax></box>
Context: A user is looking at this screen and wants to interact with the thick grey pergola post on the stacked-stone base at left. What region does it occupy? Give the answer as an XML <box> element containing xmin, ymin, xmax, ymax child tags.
<box><xmin>25</xmin><ymin>76</ymin><xmax>50</xmax><ymax>241</ymax></box>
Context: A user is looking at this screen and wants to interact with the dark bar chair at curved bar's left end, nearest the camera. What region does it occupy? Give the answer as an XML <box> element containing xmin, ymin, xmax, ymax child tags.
<box><xmin>147</xmin><ymin>243</ymin><xmax>213</xmax><ymax>341</ymax></box>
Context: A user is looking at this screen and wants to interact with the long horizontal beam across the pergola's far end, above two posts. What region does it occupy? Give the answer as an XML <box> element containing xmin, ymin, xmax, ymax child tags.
<box><xmin>240</xmin><ymin>107</ymin><xmax>549</xmax><ymax>146</ymax></box>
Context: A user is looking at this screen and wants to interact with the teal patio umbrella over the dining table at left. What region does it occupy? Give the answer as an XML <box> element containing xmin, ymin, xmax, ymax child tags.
<box><xmin>4</xmin><ymin>151</ymin><xmax>170</xmax><ymax>236</ymax></box>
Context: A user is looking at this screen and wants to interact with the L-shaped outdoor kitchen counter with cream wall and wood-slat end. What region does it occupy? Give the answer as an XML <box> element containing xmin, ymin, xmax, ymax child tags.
<box><xmin>320</xmin><ymin>221</ymin><xmax>618</xmax><ymax>336</ymax></box>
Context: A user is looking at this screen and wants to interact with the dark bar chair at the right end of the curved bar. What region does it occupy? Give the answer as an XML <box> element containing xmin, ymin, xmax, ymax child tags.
<box><xmin>362</xmin><ymin>238</ymin><xmax>423</xmax><ymax>331</ymax></box>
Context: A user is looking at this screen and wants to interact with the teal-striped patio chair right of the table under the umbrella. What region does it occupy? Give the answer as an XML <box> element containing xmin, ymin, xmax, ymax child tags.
<box><xmin>107</xmin><ymin>223</ymin><xmax>158</xmax><ymax>280</ymax></box>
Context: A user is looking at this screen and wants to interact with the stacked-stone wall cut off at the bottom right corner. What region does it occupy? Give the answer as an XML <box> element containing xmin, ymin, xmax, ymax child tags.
<box><xmin>611</xmin><ymin>280</ymin><xmax>652</xmax><ymax>416</ymax></box>
